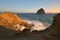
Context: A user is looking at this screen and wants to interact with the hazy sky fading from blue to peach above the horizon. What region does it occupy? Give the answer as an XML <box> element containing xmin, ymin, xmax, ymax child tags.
<box><xmin>0</xmin><ymin>0</ymin><xmax>60</xmax><ymax>12</ymax></box>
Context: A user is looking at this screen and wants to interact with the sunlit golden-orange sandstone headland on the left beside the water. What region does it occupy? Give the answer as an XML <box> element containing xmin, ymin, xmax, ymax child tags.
<box><xmin>0</xmin><ymin>12</ymin><xmax>24</xmax><ymax>30</ymax></box>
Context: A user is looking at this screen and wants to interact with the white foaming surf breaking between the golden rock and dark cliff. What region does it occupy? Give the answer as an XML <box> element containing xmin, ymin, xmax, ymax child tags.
<box><xmin>24</xmin><ymin>20</ymin><xmax>51</xmax><ymax>32</ymax></box>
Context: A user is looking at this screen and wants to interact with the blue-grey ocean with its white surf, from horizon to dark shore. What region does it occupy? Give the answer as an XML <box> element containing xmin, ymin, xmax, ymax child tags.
<box><xmin>16</xmin><ymin>13</ymin><xmax>56</xmax><ymax>30</ymax></box>
